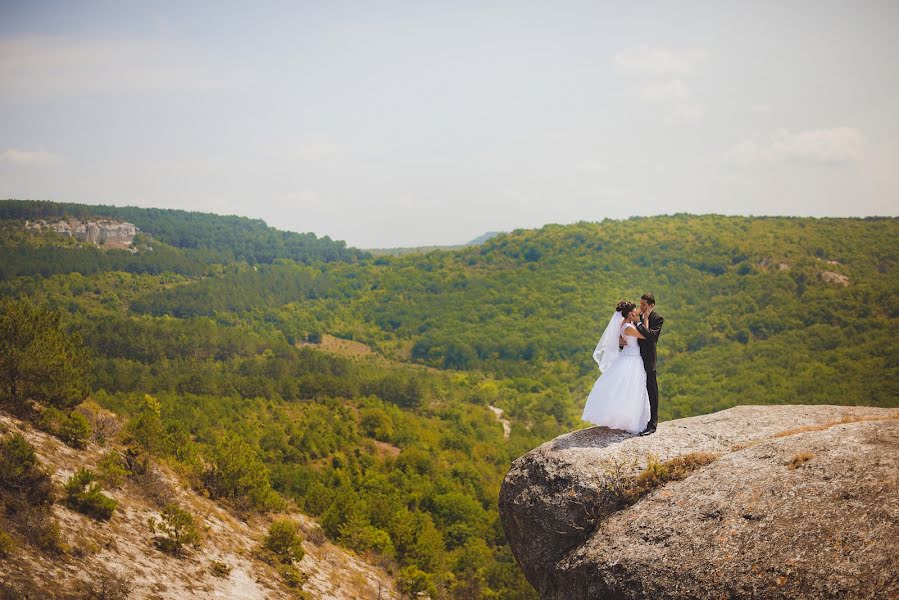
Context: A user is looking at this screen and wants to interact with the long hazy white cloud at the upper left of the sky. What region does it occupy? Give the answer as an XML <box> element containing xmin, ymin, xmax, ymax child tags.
<box><xmin>0</xmin><ymin>36</ymin><xmax>221</xmax><ymax>100</ymax></box>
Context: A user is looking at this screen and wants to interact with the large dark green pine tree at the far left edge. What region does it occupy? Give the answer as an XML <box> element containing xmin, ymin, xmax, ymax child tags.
<box><xmin>0</xmin><ymin>297</ymin><xmax>90</xmax><ymax>411</ymax></box>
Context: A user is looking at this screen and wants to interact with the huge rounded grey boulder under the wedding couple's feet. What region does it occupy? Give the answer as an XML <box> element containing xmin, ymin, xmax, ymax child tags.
<box><xmin>500</xmin><ymin>406</ymin><xmax>899</xmax><ymax>600</ymax></box>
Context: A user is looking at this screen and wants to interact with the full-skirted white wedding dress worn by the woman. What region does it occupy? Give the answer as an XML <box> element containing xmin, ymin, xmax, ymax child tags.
<box><xmin>581</xmin><ymin>323</ymin><xmax>649</xmax><ymax>433</ymax></box>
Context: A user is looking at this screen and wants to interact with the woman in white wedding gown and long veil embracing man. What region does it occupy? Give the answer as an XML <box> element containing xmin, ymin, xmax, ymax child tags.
<box><xmin>581</xmin><ymin>300</ymin><xmax>650</xmax><ymax>433</ymax></box>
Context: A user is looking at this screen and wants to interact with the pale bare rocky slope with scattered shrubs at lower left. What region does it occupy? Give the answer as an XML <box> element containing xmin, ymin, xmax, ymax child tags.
<box><xmin>0</xmin><ymin>412</ymin><xmax>399</xmax><ymax>600</ymax></box>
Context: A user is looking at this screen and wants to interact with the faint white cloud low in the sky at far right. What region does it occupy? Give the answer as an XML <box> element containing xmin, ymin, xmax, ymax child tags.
<box><xmin>727</xmin><ymin>127</ymin><xmax>864</xmax><ymax>165</ymax></box>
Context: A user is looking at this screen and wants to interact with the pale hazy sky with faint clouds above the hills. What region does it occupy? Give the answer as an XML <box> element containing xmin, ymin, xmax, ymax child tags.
<box><xmin>0</xmin><ymin>0</ymin><xmax>899</xmax><ymax>248</ymax></box>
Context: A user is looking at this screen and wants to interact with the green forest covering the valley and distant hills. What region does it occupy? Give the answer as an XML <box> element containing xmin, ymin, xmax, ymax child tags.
<box><xmin>0</xmin><ymin>200</ymin><xmax>899</xmax><ymax>599</ymax></box>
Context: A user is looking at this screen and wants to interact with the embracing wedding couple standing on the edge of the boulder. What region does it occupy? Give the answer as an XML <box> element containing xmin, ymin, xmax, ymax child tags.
<box><xmin>581</xmin><ymin>294</ymin><xmax>665</xmax><ymax>435</ymax></box>
